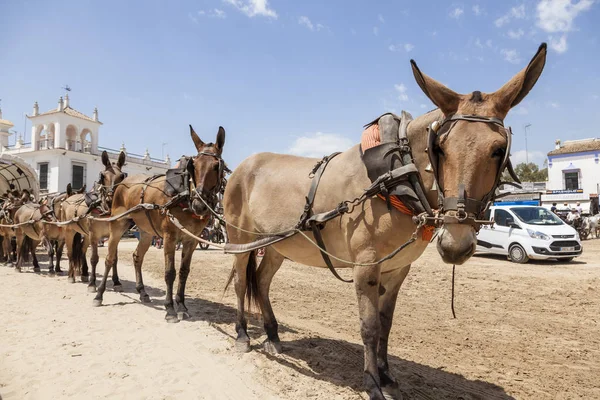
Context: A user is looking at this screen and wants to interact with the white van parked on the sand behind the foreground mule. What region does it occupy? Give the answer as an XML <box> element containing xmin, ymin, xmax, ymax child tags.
<box><xmin>477</xmin><ymin>205</ymin><xmax>583</xmax><ymax>263</ymax></box>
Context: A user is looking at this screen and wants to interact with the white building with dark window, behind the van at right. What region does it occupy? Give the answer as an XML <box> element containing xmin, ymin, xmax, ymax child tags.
<box><xmin>542</xmin><ymin>138</ymin><xmax>600</xmax><ymax>214</ymax></box>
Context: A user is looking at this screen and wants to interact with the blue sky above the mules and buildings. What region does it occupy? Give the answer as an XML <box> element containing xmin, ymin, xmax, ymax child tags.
<box><xmin>0</xmin><ymin>0</ymin><xmax>600</xmax><ymax>166</ymax></box>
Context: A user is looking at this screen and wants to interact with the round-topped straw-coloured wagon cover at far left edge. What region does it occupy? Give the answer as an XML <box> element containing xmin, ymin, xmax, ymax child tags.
<box><xmin>0</xmin><ymin>153</ymin><xmax>40</xmax><ymax>198</ymax></box>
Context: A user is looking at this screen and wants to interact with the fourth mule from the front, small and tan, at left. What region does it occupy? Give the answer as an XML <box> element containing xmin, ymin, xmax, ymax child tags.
<box><xmin>14</xmin><ymin>190</ymin><xmax>63</xmax><ymax>274</ymax></box>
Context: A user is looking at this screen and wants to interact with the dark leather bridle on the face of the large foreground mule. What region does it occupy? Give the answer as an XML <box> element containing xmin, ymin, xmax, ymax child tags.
<box><xmin>427</xmin><ymin>114</ymin><xmax>521</xmax><ymax>232</ymax></box>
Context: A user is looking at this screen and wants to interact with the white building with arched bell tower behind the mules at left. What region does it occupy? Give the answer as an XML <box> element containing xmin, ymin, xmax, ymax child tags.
<box><xmin>0</xmin><ymin>94</ymin><xmax>171</xmax><ymax>194</ymax></box>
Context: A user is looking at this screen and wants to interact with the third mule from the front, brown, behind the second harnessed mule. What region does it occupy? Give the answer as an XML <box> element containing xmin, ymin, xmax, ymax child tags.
<box><xmin>60</xmin><ymin>151</ymin><xmax>126</xmax><ymax>293</ymax></box>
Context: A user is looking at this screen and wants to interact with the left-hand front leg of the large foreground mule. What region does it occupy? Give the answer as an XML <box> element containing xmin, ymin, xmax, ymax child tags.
<box><xmin>354</xmin><ymin>249</ymin><xmax>384</xmax><ymax>400</ymax></box>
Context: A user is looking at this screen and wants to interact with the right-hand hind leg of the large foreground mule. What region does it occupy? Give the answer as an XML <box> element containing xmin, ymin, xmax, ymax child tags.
<box><xmin>257</xmin><ymin>247</ymin><xmax>284</xmax><ymax>354</ymax></box>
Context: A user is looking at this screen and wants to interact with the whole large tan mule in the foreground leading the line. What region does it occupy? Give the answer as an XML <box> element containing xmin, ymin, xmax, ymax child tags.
<box><xmin>224</xmin><ymin>44</ymin><xmax>546</xmax><ymax>400</ymax></box>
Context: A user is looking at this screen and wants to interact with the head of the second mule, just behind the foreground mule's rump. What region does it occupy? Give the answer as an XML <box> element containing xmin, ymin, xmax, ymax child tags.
<box><xmin>187</xmin><ymin>125</ymin><xmax>225</xmax><ymax>216</ymax></box>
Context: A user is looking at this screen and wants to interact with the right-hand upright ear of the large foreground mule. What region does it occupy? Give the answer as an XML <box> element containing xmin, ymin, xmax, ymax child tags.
<box><xmin>493</xmin><ymin>43</ymin><xmax>547</xmax><ymax>113</ymax></box>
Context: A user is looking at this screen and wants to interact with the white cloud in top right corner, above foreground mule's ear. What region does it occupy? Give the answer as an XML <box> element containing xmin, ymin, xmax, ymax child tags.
<box><xmin>537</xmin><ymin>0</ymin><xmax>594</xmax><ymax>33</ymax></box>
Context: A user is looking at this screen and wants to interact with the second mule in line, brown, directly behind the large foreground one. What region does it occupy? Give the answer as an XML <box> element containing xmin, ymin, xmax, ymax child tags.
<box><xmin>94</xmin><ymin>125</ymin><xmax>225</xmax><ymax>323</ymax></box>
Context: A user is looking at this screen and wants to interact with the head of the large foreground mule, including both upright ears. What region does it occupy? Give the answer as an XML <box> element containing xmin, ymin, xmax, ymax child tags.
<box><xmin>411</xmin><ymin>43</ymin><xmax>546</xmax><ymax>264</ymax></box>
